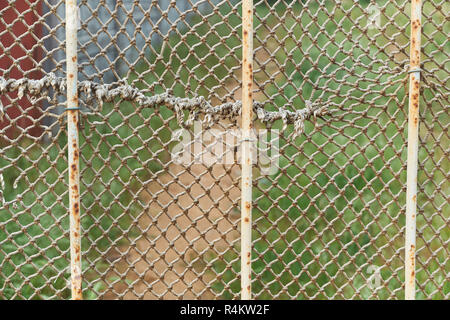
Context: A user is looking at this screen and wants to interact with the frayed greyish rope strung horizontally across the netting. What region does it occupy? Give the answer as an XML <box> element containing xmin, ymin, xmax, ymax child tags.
<box><xmin>0</xmin><ymin>73</ymin><xmax>331</xmax><ymax>135</ymax></box>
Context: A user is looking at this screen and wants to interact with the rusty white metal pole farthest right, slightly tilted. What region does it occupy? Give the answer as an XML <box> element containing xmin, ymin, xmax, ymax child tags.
<box><xmin>405</xmin><ymin>0</ymin><xmax>422</xmax><ymax>300</ymax></box>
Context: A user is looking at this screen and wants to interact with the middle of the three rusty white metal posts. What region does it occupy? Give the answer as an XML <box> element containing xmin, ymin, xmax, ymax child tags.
<box><xmin>241</xmin><ymin>0</ymin><xmax>253</xmax><ymax>300</ymax></box>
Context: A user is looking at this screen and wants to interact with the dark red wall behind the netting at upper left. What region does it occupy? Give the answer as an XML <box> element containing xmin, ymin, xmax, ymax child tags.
<box><xmin>0</xmin><ymin>0</ymin><xmax>43</xmax><ymax>138</ymax></box>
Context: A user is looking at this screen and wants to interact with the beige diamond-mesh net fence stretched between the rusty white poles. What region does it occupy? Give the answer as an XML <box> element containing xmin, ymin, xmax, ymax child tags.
<box><xmin>0</xmin><ymin>0</ymin><xmax>450</xmax><ymax>299</ymax></box>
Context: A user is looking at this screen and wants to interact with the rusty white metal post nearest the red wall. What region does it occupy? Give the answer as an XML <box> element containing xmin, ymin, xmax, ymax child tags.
<box><xmin>65</xmin><ymin>0</ymin><xmax>83</xmax><ymax>300</ymax></box>
